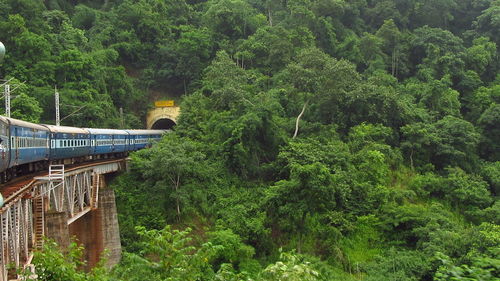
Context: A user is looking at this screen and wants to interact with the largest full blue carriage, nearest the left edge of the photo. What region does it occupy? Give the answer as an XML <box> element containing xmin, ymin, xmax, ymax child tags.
<box><xmin>2</xmin><ymin>117</ymin><xmax>49</xmax><ymax>175</ymax></box>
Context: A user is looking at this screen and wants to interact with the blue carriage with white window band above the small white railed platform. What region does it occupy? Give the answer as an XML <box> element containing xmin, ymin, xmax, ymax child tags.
<box><xmin>45</xmin><ymin>125</ymin><xmax>90</xmax><ymax>164</ymax></box>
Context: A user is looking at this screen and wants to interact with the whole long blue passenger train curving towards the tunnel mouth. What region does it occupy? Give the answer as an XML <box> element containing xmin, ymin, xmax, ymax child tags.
<box><xmin>0</xmin><ymin>116</ymin><xmax>167</xmax><ymax>183</ymax></box>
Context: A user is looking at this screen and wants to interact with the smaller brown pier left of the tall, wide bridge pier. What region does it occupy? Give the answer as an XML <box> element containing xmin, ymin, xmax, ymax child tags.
<box><xmin>45</xmin><ymin>212</ymin><xmax>70</xmax><ymax>251</ymax></box>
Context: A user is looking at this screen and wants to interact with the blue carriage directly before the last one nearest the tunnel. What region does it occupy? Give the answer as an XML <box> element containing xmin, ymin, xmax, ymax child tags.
<box><xmin>87</xmin><ymin>128</ymin><xmax>129</xmax><ymax>159</ymax></box>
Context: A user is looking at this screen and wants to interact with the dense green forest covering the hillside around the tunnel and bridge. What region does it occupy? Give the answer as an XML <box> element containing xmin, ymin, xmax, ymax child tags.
<box><xmin>0</xmin><ymin>0</ymin><xmax>500</xmax><ymax>281</ymax></box>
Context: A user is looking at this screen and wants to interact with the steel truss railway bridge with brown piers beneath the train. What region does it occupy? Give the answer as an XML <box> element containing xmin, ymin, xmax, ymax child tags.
<box><xmin>0</xmin><ymin>159</ymin><xmax>126</xmax><ymax>281</ymax></box>
